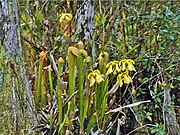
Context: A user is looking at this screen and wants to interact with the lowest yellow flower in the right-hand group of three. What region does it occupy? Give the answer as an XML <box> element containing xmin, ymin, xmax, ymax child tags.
<box><xmin>117</xmin><ymin>73</ymin><xmax>132</xmax><ymax>87</ymax></box>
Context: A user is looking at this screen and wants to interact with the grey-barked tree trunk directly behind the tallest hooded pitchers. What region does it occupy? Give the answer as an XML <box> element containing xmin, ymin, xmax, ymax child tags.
<box><xmin>76</xmin><ymin>0</ymin><xmax>95</xmax><ymax>61</ymax></box>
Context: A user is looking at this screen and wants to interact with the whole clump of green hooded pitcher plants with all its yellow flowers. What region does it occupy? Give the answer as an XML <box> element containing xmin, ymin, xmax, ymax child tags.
<box><xmin>34</xmin><ymin>13</ymin><xmax>136</xmax><ymax>134</ymax></box>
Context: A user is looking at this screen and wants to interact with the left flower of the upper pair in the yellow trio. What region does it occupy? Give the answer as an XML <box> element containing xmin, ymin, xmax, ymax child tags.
<box><xmin>106</xmin><ymin>61</ymin><xmax>121</xmax><ymax>75</ymax></box>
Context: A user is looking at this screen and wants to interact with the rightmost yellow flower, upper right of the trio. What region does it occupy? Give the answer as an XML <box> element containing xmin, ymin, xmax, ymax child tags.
<box><xmin>119</xmin><ymin>59</ymin><xmax>136</xmax><ymax>71</ymax></box>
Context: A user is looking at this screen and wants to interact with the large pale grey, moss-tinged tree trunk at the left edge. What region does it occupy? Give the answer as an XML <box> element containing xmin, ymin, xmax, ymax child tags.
<box><xmin>0</xmin><ymin>0</ymin><xmax>37</xmax><ymax>134</ymax></box>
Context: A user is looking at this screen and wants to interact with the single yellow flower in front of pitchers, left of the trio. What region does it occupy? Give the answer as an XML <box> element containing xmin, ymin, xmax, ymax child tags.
<box><xmin>88</xmin><ymin>70</ymin><xmax>104</xmax><ymax>87</ymax></box>
